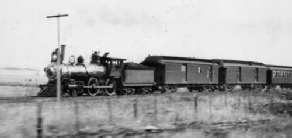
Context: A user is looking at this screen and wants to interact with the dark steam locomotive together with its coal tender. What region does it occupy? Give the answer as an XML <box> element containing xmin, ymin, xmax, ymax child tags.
<box><xmin>38</xmin><ymin>46</ymin><xmax>155</xmax><ymax>96</ymax></box>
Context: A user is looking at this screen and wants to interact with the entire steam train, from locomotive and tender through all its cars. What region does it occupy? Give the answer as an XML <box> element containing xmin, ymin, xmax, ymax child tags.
<box><xmin>38</xmin><ymin>46</ymin><xmax>292</xmax><ymax>96</ymax></box>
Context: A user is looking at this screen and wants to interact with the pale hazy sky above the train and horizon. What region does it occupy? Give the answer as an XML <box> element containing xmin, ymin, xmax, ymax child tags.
<box><xmin>0</xmin><ymin>0</ymin><xmax>292</xmax><ymax>70</ymax></box>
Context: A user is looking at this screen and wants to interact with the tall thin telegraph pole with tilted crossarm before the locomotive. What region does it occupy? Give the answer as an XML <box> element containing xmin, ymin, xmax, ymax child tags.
<box><xmin>47</xmin><ymin>14</ymin><xmax>68</xmax><ymax>103</ymax></box>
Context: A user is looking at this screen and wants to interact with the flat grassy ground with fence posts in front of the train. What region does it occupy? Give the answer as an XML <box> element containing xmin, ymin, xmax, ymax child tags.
<box><xmin>0</xmin><ymin>86</ymin><xmax>292</xmax><ymax>137</ymax></box>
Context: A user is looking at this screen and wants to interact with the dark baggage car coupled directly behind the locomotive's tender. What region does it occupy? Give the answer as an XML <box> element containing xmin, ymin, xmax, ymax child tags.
<box><xmin>141</xmin><ymin>56</ymin><xmax>218</xmax><ymax>92</ymax></box>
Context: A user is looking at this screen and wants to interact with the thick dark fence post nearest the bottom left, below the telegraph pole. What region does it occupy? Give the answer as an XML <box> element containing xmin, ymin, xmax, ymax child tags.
<box><xmin>36</xmin><ymin>102</ymin><xmax>43</xmax><ymax>138</ymax></box>
